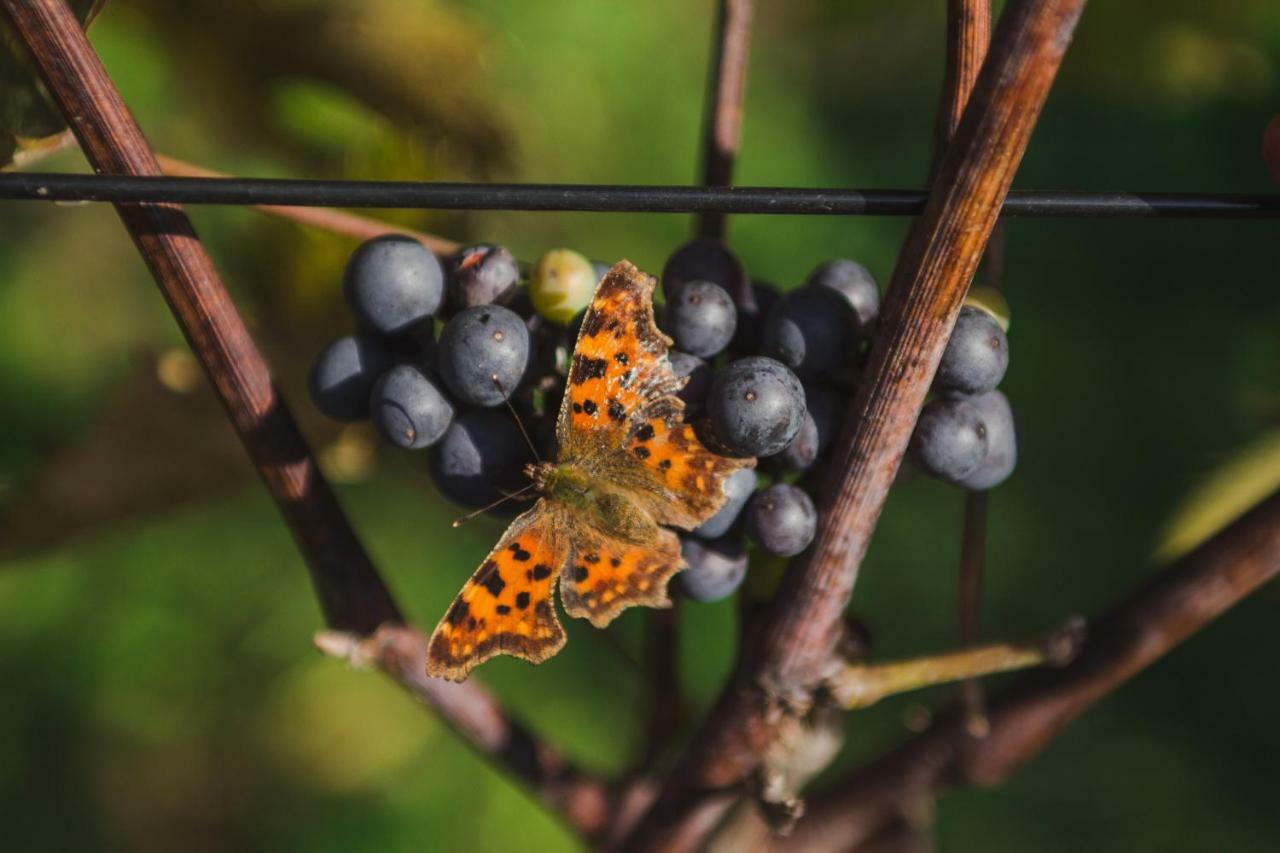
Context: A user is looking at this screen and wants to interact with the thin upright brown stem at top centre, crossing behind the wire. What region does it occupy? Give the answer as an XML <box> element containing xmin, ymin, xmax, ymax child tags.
<box><xmin>698</xmin><ymin>0</ymin><xmax>755</xmax><ymax>238</ymax></box>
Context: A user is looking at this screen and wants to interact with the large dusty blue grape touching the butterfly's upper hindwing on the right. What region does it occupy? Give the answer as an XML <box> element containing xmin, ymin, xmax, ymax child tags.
<box><xmin>707</xmin><ymin>356</ymin><xmax>804</xmax><ymax>456</ymax></box>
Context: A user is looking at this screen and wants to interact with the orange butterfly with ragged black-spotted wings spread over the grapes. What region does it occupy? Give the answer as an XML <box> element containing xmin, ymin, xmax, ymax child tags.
<box><xmin>426</xmin><ymin>260</ymin><xmax>755</xmax><ymax>681</ymax></box>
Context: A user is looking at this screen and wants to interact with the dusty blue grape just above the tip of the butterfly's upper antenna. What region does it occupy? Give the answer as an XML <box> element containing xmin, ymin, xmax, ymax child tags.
<box><xmin>438</xmin><ymin>305</ymin><xmax>530</xmax><ymax>406</ymax></box>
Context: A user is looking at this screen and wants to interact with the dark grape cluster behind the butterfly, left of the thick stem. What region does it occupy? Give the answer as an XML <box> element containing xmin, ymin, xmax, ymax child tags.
<box><xmin>310</xmin><ymin>236</ymin><xmax>896</xmax><ymax>601</ymax></box>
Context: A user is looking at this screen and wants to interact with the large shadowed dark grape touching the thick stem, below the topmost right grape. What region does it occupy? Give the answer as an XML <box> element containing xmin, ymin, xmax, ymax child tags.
<box><xmin>760</xmin><ymin>284</ymin><xmax>859</xmax><ymax>377</ymax></box>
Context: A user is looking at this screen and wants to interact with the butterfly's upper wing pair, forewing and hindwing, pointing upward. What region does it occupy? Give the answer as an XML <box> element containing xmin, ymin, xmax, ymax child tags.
<box><xmin>558</xmin><ymin>261</ymin><xmax>755</xmax><ymax>529</ymax></box>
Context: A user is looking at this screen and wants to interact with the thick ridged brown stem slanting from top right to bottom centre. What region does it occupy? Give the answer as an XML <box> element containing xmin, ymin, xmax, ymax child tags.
<box><xmin>630</xmin><ymin>0</ymin><xmax>1084</xmax><ymax>849</ymax></box>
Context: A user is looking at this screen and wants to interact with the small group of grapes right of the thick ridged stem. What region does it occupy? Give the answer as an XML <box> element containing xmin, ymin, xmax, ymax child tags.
<box><xmin>911</xmin><ymin>288</ymin><xmax>1018</xmax><ymax>491</ymax></box>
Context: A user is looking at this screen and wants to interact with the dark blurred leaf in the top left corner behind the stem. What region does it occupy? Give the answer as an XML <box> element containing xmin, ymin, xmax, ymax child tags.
<box><xmin>0</xmin><ymin>0</ymin><xmax>106</xmax><ymax>168</ymax></box>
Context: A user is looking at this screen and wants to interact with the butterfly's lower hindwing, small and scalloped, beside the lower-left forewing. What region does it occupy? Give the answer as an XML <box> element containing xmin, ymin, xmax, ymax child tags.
<box><xmin>561</xmin><ymin>528</ymin><xmax>684</xmax><ymax>628</ymax></box>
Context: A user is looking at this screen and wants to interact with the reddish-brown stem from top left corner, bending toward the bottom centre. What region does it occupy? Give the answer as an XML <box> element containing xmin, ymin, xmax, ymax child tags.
<box><xmin>0</xmin><ymin>0</ymin><xmax>604</xmax><ymax>835</ymax></box>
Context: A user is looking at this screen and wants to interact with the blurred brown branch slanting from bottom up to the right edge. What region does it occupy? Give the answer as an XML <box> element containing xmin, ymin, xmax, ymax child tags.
<box><xmin>778</xmin><ymin>492</ymin><xmax>1280</xmax><ymax>852</ymax></box>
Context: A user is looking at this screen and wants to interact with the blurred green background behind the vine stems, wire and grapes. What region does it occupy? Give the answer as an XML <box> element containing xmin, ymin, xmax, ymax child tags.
<box><xmin>0</xmin><ymin>0</ymin><xmax>1280</xmax><ymax>852</ymax></box>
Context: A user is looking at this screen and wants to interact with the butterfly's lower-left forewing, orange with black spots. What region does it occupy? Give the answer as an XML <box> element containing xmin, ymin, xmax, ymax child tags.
<box><xmin>426</xmin><ymin>500</ymin><xmax>570</xmax><ymax>681</ymax></box>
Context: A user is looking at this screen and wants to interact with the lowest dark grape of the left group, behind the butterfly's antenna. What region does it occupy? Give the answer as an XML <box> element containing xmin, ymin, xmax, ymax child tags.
<box><xmin>428</xmin><ymin>410</ymin><xmax>530</xmax><ymax>508</ymax></box>
